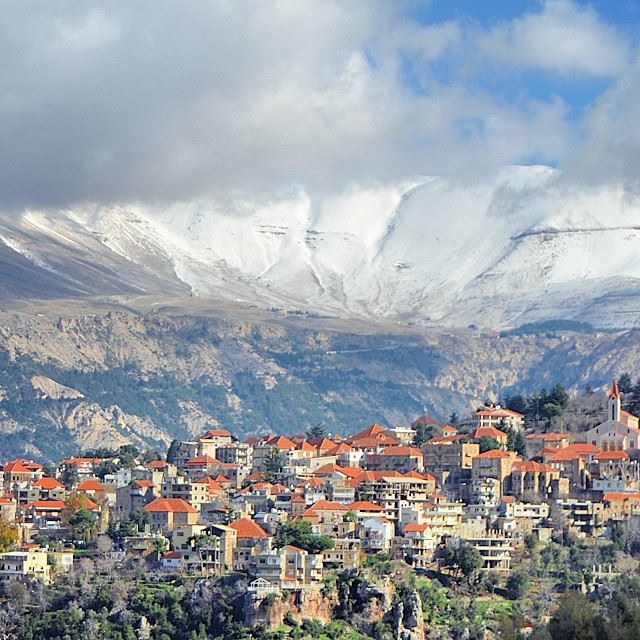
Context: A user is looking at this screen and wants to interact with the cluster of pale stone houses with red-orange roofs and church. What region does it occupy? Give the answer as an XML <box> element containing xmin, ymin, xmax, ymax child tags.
<box><xmin>0</xmin><ymin>382</ymin><xmax>640</xmax><ymax>593</ymax></box>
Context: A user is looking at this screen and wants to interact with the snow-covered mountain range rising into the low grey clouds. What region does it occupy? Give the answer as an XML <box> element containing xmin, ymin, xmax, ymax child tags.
<box><xmin>0</xmin><ymin>166</ymin><xmax>640</xmax><ymax>328</ymax></box>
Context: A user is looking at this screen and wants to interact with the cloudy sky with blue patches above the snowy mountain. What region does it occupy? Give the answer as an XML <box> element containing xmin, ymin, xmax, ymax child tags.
<box><xmin>0</xmin><ymin>0</ymin><xmax>640</xmax><ymax>211</ymax></box>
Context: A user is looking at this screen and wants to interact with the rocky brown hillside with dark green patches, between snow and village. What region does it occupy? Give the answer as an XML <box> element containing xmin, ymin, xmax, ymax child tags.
<box><xmin>0</xmin><ymin>299</ymin><xmax>640</xmax><ymax>459</ymax></box>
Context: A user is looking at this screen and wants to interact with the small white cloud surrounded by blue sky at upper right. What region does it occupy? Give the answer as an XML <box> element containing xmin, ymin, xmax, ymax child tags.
<box><xmin>478</xmin><ymin>0</ymin><xmax>629</xmax><ymax>76</ymax></box>
